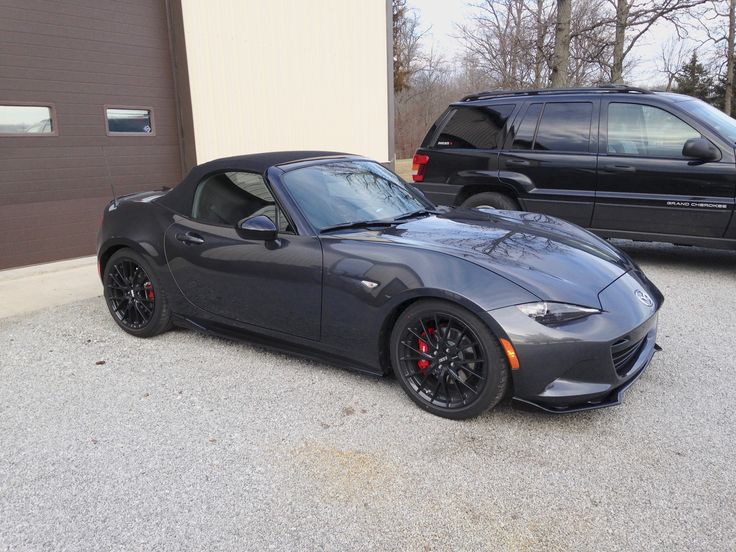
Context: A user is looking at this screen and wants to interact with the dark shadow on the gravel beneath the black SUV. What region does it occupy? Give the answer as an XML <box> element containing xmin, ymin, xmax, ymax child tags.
<box><xmin>611</xmin><ymin>240</ymin><xmax>736</xmax><ymax>269</ymax></box>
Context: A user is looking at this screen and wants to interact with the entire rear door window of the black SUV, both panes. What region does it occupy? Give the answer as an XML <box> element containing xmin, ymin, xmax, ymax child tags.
<box><xmin>511</xmin><ymin>102</ymin><xmax>593</xmax><ymax>152</ymax></box>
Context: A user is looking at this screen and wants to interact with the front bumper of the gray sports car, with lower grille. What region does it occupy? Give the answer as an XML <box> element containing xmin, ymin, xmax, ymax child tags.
<box><xmin>489</xmin><ymin>272</ymin><xmax>663</xmax><ymax>413</ymax></box>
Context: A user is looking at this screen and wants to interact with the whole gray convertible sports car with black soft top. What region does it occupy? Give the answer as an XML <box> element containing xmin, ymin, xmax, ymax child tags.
<box><xmin>98</xmin><ymin>152</ymin><xmax>663</xmax><ymax>419</ymax></box>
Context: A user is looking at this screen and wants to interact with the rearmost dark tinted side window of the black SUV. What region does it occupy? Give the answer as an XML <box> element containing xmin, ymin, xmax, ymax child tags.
<box><xmin>435</xmin><ymin>104</ymin><xmax>514</xmax><ymax>149</ymax></box>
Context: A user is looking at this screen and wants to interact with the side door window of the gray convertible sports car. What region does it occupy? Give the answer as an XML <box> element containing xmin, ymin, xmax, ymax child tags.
<box><xmin>192</xmin><ymin>171</ymin><xmax>293</xmax><ymax>232</ymax></box>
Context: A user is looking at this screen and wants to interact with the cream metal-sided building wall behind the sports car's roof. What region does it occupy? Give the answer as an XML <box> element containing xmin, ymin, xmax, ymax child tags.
<box><xmin>181</xmin><ymin>0</ymin><xmax>393</xmax><ymax>163</ymax></box>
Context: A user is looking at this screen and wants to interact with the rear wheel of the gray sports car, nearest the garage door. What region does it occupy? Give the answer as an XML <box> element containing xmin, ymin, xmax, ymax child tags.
<box><xmin>103</xmin><ymin>248</ymin><xmax>172</xmax><ymax>337</ymax></box>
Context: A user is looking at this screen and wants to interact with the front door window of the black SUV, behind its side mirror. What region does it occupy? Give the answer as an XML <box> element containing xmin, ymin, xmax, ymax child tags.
<box><xmin>608</xmin><ymin>103</ymin><xmax>701</xmax><ymax>157</ymax></box>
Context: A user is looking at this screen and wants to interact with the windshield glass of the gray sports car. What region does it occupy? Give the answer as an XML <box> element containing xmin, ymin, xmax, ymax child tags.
<box><xmin>282</xmin><ymin>161</ymin><xmax>434</xmax><ymax>231</ymax></box>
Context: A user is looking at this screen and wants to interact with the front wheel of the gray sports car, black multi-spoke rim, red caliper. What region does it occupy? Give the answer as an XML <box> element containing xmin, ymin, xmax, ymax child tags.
<box><xmin>391</xmin><ymin>299</ymin><xmax>509</xmax><ymax>420</ymax></box>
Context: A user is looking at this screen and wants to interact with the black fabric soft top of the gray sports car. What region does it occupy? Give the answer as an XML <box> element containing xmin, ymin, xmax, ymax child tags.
<box><xmin>155</xmin><ymin>151</ymin><xmax>351</xmax><ymax>213</ymax></box>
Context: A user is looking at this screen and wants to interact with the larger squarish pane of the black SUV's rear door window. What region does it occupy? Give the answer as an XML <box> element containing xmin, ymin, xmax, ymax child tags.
<box><xmin>534</xmin><ymin>102</ymin><xmax>593</xmax><ymax>153</ymax></box>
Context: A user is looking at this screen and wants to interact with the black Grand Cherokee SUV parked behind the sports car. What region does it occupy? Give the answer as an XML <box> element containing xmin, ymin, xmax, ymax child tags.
<box><xmin>413</xmin><ymin>86</ymin><xmax>736</xmax><ymax>249</ymax></box>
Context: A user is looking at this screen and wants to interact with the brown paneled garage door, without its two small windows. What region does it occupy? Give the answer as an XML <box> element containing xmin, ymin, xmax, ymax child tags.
<box><xmin>0</xmin><ymin>0</ymin><xmax>181</xmax><ymax>269</ymax></box>
